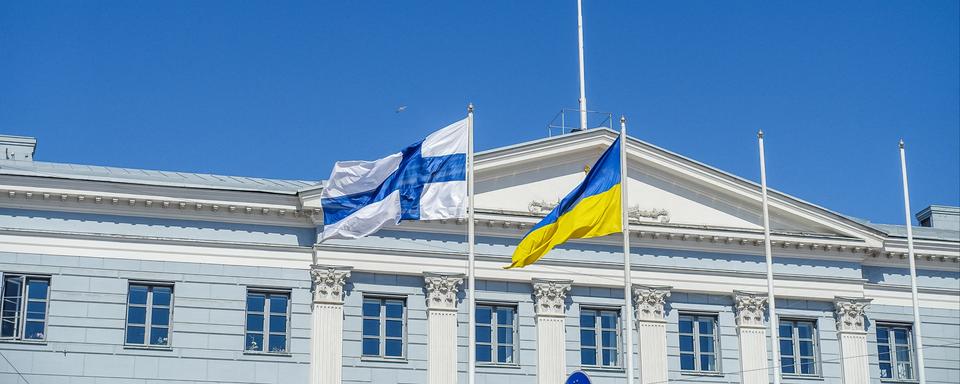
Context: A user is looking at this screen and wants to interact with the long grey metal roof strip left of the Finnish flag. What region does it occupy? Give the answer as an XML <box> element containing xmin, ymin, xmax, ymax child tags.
<box><xmin>0</xmin><ymin>160</ymin><xmax>320</xmax><ymax>194</ymax></box>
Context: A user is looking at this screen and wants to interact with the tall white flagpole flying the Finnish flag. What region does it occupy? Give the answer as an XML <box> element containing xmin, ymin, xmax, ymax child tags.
<box><xmin>467</xmin><ymin>103</ymin><xmax>477</xmax><ymax>384</ymax></box>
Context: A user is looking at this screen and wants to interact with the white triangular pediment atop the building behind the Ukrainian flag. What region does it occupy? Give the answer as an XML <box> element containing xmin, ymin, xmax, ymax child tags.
<box><xmin>476</xmin><ymin>129</ymin><xmax>875</xmax><ymax>239</ymax></box>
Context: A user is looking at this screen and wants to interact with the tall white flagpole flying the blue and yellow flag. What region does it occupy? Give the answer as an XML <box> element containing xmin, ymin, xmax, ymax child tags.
<box><xmin>620</xmin><ymin>115</ymin><xmax>633</xmax><ymax>384</ymax></box>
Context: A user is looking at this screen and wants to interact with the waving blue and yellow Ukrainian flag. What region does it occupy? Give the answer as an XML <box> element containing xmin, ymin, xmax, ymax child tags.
<box><xmin>505</xmin><ymin>137</ymin><xmax>623</xmax><ymax>269</ymax></box>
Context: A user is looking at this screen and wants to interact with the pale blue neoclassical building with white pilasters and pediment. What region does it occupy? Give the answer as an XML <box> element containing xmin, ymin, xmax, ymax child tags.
<box><xmin>0</xmin><ymin>129</ymin><xmax>960</xmax><ymax>384</ymax></box>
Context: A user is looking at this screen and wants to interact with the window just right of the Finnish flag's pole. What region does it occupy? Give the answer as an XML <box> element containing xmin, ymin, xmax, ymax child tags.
<box><xmin>476</xmin><ymin>305</ymin><xmax>517</xmax><ymax>364</ymax></box>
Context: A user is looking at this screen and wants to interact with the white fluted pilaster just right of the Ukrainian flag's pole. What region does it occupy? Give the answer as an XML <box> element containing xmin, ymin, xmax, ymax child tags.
<box><xmin>628</xmin><ymin>285</ymin><xmax>671</xmax><ymax>383</ymax></box>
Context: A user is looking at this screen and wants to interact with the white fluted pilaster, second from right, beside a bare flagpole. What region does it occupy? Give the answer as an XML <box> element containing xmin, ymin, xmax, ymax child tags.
<box><xmin>734</xmin><ymin>291</ymin><xmax>776</xmax><ymax>384</ymax></box>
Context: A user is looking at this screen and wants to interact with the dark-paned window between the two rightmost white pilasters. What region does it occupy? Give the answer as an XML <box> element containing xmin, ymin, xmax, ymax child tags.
<box><xmin>779</xmin><ymin>320</ymin><xmax>819</xmax><ymax>376</ymax></box>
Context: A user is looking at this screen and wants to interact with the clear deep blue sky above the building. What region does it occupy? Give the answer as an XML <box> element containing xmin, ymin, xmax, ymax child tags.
<box><xmin>0</xmin><ymin>0</ymin><xmax>960</xmax><ymax>223</ymax></box>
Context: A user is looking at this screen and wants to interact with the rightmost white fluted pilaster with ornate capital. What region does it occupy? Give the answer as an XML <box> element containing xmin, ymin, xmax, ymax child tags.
<box><xmin>834</xmin><ymin>296</ymin><xmax>870</xmax><ymax>384</ymax></box>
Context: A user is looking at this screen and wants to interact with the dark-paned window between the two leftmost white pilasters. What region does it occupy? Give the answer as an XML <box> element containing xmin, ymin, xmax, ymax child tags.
<box><xmin>363</xmin><ymin>297</ymin><xmax>406</xmax><ymax>358</ymax></box>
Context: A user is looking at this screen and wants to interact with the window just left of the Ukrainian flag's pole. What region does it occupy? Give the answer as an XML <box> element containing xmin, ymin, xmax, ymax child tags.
<box><xmin>580</xmin><ymin>309</ymin><xmax>620</xmax><ymax>367</ymax></box>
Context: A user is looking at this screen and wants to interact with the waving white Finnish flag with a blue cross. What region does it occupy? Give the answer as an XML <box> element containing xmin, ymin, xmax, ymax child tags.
<box><xmin>320</xmin><ymin>119</ymin><xmax>468</xmax><ymax>241</ymax></box>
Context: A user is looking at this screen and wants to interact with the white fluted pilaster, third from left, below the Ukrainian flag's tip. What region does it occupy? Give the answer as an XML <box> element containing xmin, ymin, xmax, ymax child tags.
<box><xmin>533</xmin><ymin>279</ymin><xmax>572</xmax><ymax>384</ymax></box>
